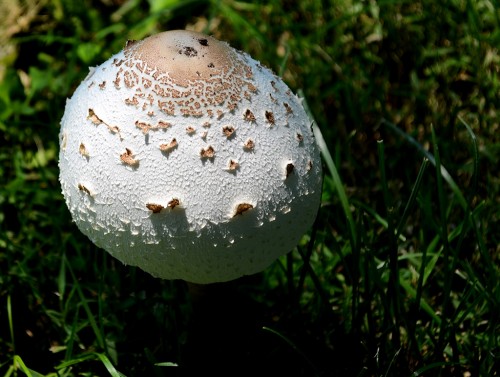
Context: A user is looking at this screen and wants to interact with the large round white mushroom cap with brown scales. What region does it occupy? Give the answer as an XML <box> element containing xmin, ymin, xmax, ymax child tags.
<box><xmin>59</xmin><ymin>31</ymin><xmax>321</xmax><ymax>283</ymax></box>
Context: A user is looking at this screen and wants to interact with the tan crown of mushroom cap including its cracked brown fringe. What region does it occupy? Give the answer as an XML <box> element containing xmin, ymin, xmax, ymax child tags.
<box><xmin>118</xmin><ymin>30</ymin><xmax>257</xmax><ymax>117</ymax></box>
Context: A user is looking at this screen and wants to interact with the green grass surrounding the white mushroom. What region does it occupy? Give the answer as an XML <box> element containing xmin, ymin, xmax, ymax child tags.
<box><xmin>0</xmin><ymin>0</ymin><xmax>500</xmax><ymax>376</ymax></box>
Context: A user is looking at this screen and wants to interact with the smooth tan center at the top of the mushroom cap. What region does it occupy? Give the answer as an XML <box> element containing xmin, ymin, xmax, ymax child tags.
<box><xmin>133</xmin><ymin>30</ymin><xmax>235</xmax><ymax>86</ymax></box>
